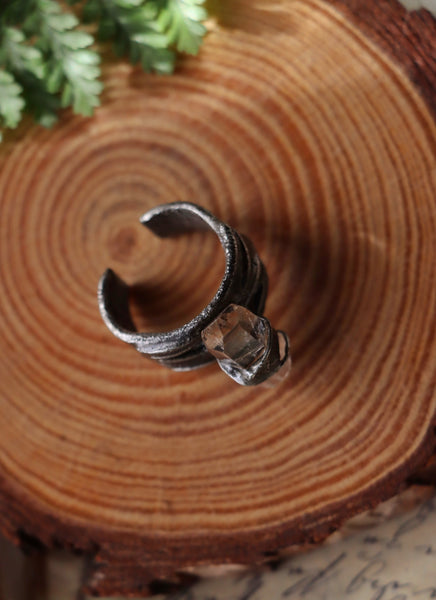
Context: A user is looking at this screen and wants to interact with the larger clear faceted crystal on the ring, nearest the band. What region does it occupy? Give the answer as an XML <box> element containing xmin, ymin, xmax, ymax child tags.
<box><xmin>202</xmin><ymin>304</ymin><xmax>268</xmax><ymax>369</ymax></box>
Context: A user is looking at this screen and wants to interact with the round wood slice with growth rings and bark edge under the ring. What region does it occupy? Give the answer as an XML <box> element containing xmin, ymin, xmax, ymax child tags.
<box><xmin>0</xmin><ymin>0</ymin><xmax>436</xmax><ymax>595</ymax></box>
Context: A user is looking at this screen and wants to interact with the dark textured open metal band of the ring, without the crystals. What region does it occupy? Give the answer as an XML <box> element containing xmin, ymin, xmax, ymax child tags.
<box><xmin>98</xmin><ymin>202</ymin><xmax>270</xmax><ymax>370</ymax></box>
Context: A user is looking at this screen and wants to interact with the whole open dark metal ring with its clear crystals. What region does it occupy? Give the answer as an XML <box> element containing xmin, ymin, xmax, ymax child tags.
<box><xmin>98</xmin><ymin>202</ymin><xmax>291</xmax><ymax>386</ymax></box>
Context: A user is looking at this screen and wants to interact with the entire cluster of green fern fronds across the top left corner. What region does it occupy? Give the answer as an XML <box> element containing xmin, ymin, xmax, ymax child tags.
<box><xmin>0</xmin><ymin>0</ymin><xmax>207</xmax><ymax>141</ymax></box>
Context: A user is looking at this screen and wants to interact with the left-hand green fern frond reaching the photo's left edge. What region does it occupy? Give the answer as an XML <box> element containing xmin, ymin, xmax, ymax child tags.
<box><xmin>0</xmin><ymin>0</ymin><xmax>102</xmax><ymax>138</ymax></box>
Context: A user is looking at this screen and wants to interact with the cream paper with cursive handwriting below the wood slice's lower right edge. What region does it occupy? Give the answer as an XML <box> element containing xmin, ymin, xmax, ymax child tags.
<box><xmin>169</xmin><ymin>495</ymin><xmax>436</xmax><ymax>600</ymax></box>
